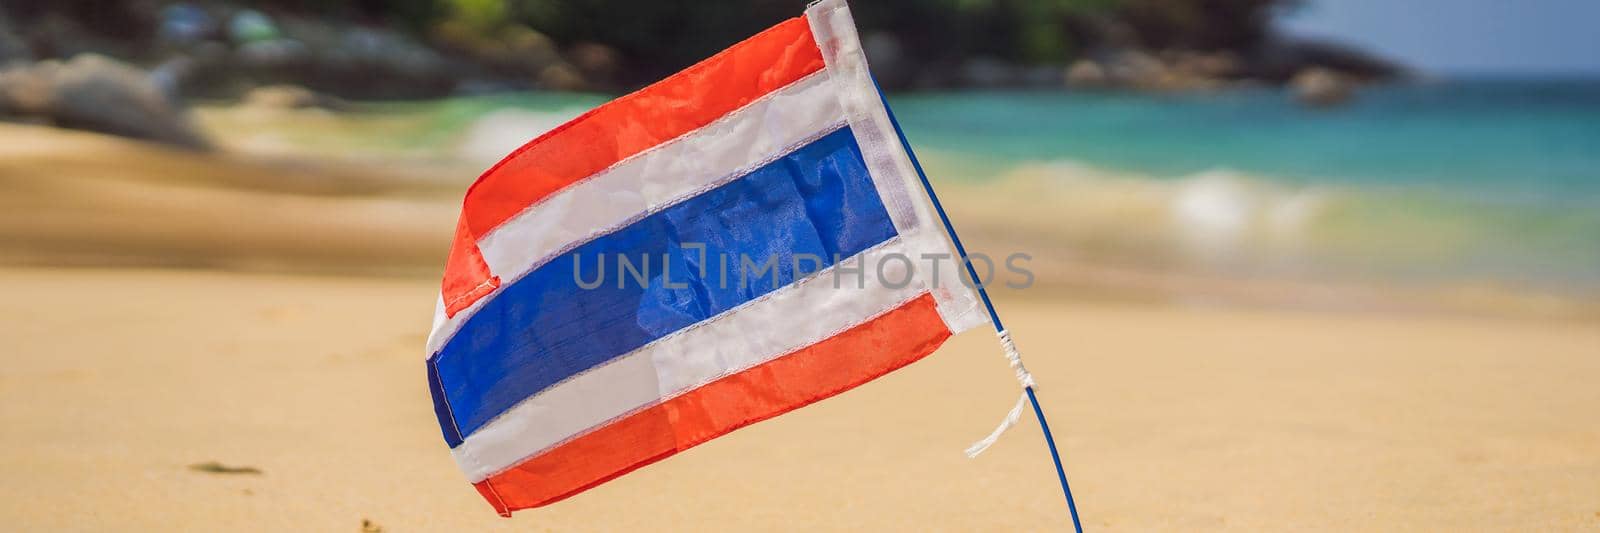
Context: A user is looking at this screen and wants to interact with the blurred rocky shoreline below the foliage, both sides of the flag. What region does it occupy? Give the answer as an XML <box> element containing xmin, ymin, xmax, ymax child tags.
<box><xmin>0</xmin><ymin>3</ymin><xmax>1405</xmax><ymax>149</ymax></box>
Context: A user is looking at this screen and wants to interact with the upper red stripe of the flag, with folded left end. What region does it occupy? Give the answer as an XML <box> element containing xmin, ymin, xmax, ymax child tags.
<box><xmin>443</xmin><ymin>16</ymin><xmax>822</xmax><ymax>317</ymax></box>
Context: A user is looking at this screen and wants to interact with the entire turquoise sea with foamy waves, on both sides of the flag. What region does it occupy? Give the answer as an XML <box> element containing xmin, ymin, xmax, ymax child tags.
<box><xmin>328</xmin><ymin>80</ymin><xmax>1600</xmax><ymax>291</ymax></box>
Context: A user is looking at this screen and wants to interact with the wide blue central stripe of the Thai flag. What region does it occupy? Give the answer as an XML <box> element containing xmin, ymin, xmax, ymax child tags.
<box><xmin>429</xmin><ymin>128</ymin><xmax>894</xmax><ymax>447</ymax></box>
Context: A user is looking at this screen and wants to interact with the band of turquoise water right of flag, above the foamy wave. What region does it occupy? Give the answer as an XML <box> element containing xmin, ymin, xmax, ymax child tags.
<box><xmin>891</xmin><ymin>82</ymin><xmax>1600</xmax><ymax>200</ymax></box>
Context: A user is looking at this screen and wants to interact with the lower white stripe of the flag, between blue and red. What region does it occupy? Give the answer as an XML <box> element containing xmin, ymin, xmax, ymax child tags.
<box><xmin>451</xmin><ymin>234</ymin><xmax>952</xmax><ymax>482</ymax></box>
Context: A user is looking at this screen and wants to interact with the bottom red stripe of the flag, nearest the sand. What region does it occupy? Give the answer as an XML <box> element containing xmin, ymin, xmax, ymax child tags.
<box><xmin>474</xmin><ymin>295</ymin><xmax>950</xmax><ymax>515</ymax></box>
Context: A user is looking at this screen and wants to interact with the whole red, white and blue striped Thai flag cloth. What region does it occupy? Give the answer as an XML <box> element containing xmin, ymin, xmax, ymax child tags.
<box><xmin>427</xmin><ymin>0</ymin><xmax>987</xmax><ymax>515</ymax></box>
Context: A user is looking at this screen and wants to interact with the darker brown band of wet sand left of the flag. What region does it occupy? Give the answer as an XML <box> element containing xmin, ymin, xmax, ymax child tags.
<box><xmin>0</xmin><ymin>123</ymin><xmax>466</xmax><ymax>277</ymax></box>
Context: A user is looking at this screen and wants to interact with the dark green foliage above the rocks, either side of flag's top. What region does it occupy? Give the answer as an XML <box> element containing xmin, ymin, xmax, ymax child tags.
<box><xmin>442</xmin><ymin>0</ymin><xmax>1288</xmax><ymax>78</ymax></box>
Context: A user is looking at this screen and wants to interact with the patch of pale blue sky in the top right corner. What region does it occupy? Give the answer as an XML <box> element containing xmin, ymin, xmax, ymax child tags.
<box><xmin>1282</xmin><ymin>0</ymin><xmax>1600</xmax><ymax>75</ymax></box>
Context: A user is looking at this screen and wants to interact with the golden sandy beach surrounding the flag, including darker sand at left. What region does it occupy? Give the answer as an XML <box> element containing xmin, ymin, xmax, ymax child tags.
<box><xmin>0</xmin><ymin>117</ymin><xmax>1600</xmax><ymax>531</ymax></box>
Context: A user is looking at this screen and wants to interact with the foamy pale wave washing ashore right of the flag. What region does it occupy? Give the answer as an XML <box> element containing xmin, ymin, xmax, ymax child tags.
<box><xmin>923</xmin><ymin>154</ymin><xmax>1600</xmax><ymax>288</ymax></box>
